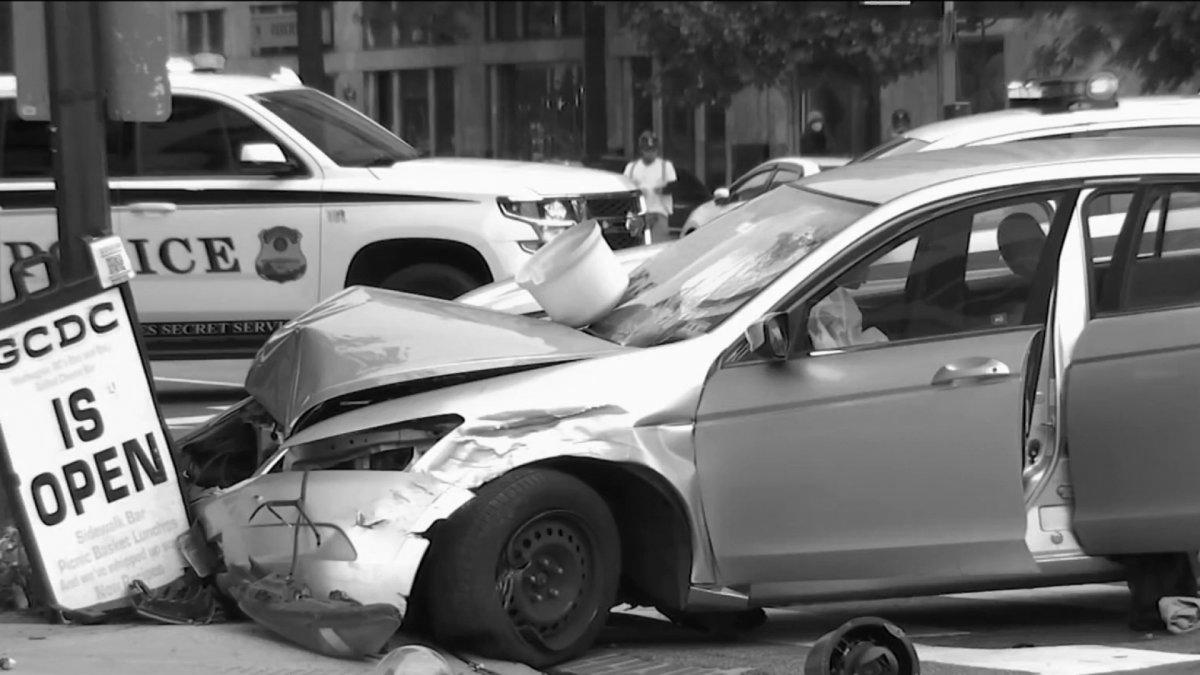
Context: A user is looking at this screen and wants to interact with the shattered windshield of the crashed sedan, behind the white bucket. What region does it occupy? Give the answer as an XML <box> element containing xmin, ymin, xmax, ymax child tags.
<box><xmin>589</xmin><ymin>186</ymin><xmax>872</xmax><ymax>347</ymax></box>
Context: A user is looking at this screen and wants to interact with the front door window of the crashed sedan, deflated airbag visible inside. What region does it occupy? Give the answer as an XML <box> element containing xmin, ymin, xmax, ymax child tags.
<box><xmin>806</xmin><ymin>193</ymin><xmax>1063</xmax><ymax>351</ymax></box>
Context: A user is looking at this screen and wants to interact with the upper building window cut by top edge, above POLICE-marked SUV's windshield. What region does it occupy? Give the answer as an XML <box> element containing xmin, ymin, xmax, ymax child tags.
<box><xmin>362</xmin><ymin>0</ymin><xmax>472</xmax><ymax>49</ymax></box>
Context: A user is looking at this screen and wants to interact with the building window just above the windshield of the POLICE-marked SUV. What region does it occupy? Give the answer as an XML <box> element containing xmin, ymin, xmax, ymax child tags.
<box><xmin>370</xmin><ymin>68</ymin><xmax>457</xmax><ymax>156</ymax></box>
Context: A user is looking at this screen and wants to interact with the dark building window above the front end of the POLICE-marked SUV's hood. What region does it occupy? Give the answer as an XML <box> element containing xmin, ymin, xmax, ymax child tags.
<box><xmin>491</xmin><ymin>64</ymin><xmax>583</xmax><ymax>161</ymax></box>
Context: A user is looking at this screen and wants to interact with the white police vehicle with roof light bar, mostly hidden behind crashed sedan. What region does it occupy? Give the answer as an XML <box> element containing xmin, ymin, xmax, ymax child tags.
<box><xmin>854</xmin><ymin>73</ymin><xmax>1200</xmax><ymax>162</ymax></box>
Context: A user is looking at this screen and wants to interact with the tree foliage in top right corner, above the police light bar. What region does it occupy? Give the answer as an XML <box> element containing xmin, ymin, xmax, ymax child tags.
<box><xmin>1034</xmin><ymin>2</ymin><xmax>1200</xmax><ymax>92</ymax></box>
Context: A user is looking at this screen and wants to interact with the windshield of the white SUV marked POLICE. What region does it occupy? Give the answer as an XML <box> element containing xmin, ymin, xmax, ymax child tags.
<box><xmin>254</xmin><ymin>89</ymin><xmax>418</xmax><ymax>167</ymax></box>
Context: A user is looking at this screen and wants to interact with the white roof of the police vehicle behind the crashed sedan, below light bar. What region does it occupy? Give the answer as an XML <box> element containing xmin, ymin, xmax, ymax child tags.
<box><xmin>905</xmin><ymin>96</ymin><xmax>1200</xmax><ymax>144</ymax></box>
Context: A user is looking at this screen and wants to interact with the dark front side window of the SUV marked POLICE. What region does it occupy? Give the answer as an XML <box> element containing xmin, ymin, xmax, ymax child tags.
<box><xmin>137</xmin><ymin>96</ymin><xmax>290</xmax><ymax>175</ymax></box>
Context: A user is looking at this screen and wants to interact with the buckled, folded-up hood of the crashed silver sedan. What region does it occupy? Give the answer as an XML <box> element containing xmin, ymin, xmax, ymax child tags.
<box><xmin>246</xmin><ymin>286</ymin><xmax>623</xmax><ymax>431</ymax></box>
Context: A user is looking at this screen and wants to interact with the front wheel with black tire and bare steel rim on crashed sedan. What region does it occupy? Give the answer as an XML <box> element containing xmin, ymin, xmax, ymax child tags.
<box><xmin>419</xmin><ymin>468</ymin><xmax>620</xmax><ymax>668</ymax></box>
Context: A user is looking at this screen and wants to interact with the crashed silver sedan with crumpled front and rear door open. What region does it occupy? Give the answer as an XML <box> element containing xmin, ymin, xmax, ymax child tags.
<box><xmin>180</xmin><ymin>139</ymin><xmax>1200</xmax><ymax>665</ymax></box>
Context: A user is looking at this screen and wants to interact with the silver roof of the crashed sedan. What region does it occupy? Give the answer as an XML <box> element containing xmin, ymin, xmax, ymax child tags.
<box><xmin>791</xmin><ymin>137</ymin><xmax>1200</xmax><ymax>204</ymax></box>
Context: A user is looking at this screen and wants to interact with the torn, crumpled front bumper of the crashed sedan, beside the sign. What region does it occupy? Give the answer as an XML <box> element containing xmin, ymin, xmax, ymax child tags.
<box><xmin>196</xmin><ymin>471</ymin><xmax>473</xmax><ymax>614</ymax></box>
